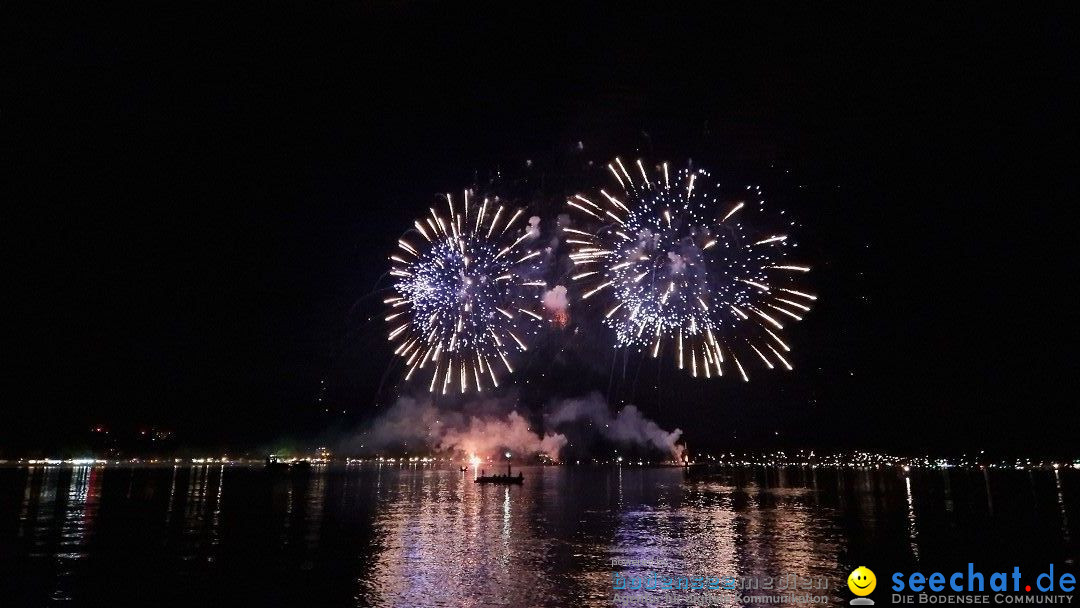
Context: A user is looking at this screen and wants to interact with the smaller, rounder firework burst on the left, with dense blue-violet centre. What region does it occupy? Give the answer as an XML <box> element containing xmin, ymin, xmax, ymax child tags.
<box><xmin>384</xmin><ymin>190</ymin><xmax>546</xmax><ymax>394</ymax></box>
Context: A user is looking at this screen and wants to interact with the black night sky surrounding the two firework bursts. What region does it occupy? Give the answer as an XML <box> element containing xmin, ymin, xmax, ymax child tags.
<box><xmin>0</xmin><ymin>2</ymin><xmax>1080</xmax><ymax>455</ymax></box>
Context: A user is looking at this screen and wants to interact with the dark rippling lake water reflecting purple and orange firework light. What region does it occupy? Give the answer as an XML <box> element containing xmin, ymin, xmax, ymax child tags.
<box><xmin>0</xmin><ymin>463</ymin><xmax>1080</xmax><ymax>607</ymax></box>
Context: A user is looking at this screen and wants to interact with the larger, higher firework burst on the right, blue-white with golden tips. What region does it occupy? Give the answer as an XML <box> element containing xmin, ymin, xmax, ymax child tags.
<box><xmin>564</xmin><ymin>158</ymin><xmax>816</xmax><ymax>381</ymax></box>
